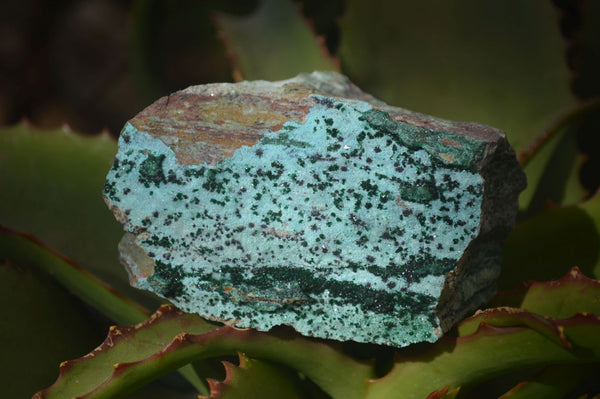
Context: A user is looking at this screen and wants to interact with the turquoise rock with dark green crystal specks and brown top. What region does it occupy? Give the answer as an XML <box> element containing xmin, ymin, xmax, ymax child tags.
<box><xmin>104</xmin><ymin>72</ymin><xmax>525</xmax><ymax>347</ymax></box>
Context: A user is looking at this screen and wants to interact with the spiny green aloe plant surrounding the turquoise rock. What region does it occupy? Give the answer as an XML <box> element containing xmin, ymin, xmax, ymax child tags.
<box><xmin>0</xmin><ymin>1</ymin><xmax>600</xmax><ymax>398</ymax></box>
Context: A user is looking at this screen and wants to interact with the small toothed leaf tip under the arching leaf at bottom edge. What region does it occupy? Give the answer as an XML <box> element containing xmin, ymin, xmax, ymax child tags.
<box><xmin>201</xmin><ymin>353</ymin><xmax>305</xmax><ymax>399</ymax></box>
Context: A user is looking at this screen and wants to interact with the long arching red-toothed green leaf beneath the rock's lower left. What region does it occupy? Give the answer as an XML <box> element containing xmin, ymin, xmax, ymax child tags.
<box><xmin>39</xmin><ymin>306</ymin><xmax>374</xmax><ymax>398</ymax></box>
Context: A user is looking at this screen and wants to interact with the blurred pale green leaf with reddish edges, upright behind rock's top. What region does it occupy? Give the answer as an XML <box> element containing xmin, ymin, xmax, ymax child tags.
<box><xmin>215</xmin><ymin>0</ymin><xmax>339</xmax><ymax>80</ymax></box>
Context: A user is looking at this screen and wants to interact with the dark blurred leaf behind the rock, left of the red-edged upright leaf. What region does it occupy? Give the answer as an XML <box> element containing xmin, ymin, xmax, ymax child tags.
<box><xmin>128</xmin><ymin>0</ymin><xmax>234</xmax><ymax>103</ymax></box>
